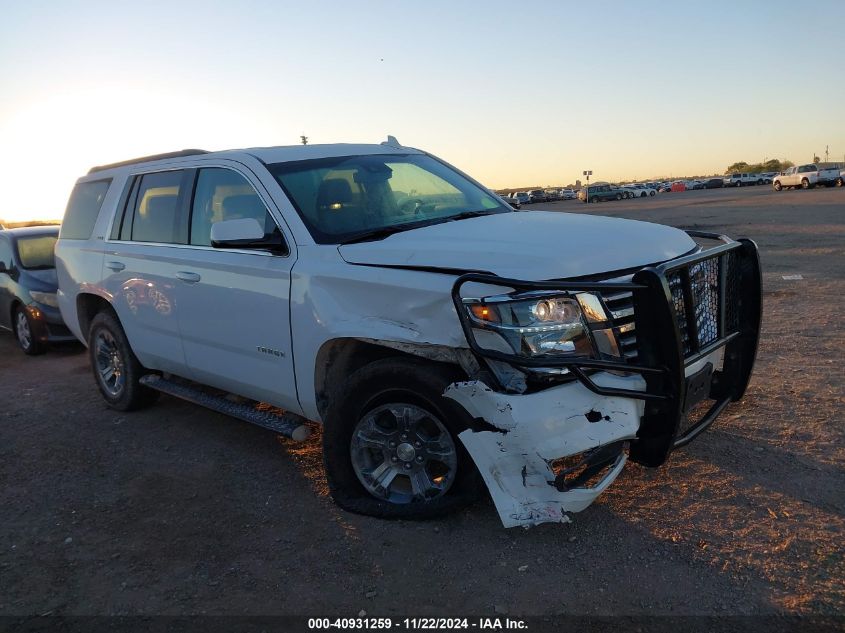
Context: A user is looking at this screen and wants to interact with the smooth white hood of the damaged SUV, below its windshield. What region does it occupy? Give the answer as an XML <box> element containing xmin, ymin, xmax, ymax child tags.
<box><xmin>338</xmin><ymin>211</ymin><xmax>696</xmax><ymax>281</ymax></box>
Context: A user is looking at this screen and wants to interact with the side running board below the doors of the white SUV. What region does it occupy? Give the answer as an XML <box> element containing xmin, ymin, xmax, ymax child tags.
<box><xmin>139</xmin><ymin>374</ymin><xmax>311</xmax><ymax>442</ymax></box>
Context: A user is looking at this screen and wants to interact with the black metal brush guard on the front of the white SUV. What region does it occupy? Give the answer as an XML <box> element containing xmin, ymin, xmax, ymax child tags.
<box><xmin>452</xmin><ymin>231</ymin><xmax>762</xmax><ymax>466</ymax></box>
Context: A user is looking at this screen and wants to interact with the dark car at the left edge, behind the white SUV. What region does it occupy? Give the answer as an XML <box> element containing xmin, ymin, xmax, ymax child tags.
<box><xmin>0</xmin><ymin>226</ymin><xmax>76</xmax><ymax>354</ymax></box>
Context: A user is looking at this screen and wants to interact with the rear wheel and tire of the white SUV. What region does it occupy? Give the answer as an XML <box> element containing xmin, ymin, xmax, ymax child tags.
<box><xmin>88</xmin><ymin>312</ymin><xmax>159</xmax><ymax>411</ymax></box>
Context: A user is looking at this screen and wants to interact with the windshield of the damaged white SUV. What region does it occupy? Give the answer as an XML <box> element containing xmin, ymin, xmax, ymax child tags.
<box><xmin>268</xmin><ymin>154</ymin><xmax>513</xmax><ymax>244</ymax></box>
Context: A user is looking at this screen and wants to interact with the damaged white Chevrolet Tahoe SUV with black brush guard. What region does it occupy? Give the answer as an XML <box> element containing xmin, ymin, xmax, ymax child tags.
<box><xmin>56</xmin><ymin>137</ymin><xmax>761</xmax><ymax>527</ymax></box>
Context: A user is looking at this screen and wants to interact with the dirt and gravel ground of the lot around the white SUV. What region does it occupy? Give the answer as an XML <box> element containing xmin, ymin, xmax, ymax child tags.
<box><xmin>0</xmin><ymin>187</ymin><xmax>845</xmax><ymax>617</ymax></box>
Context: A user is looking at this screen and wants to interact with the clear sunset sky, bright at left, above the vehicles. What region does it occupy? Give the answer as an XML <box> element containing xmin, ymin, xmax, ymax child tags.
<box><xmin>0</xmin><ymin>0</ymin><xmax>845</xmax><ymax>220</ymax></box>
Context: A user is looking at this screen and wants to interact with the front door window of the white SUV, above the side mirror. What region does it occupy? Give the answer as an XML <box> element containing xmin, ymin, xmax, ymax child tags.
<box><xmin>190</xmin><ymin>167</ymin><xmax>280</xmax><ymax>246</ymax></box>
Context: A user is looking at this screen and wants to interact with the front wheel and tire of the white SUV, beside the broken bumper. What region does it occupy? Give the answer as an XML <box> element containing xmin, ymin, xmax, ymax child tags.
<box><xmin>323</xmin><ymin>358</ymin><xmax>481</xmax><ymax>519</ymax></box>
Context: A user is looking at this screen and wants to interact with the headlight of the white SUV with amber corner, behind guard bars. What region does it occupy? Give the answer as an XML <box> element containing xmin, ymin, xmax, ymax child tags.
<box><xmin>464</xmin><ymin>293</ymin><xmax>605</xmax><ymax>358</ymax></box>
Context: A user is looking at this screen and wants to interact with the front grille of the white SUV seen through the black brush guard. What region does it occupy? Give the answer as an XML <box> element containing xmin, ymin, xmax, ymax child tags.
<box><xmin>602</xmin><ymin>251</ymin><xmax>741</xmax><ymax>363</ymax></box>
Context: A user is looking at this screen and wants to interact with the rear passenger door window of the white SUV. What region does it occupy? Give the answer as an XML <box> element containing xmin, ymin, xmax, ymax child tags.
<box><xmin>122</xmin><ymin>170</ymin><xmax>188</xmax><ymax>244</ymax></box>
